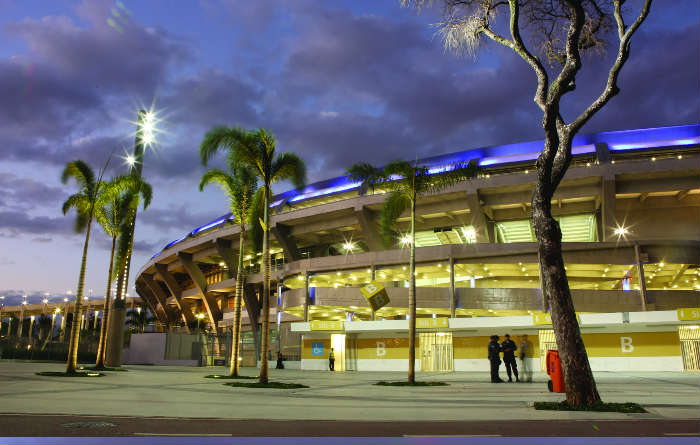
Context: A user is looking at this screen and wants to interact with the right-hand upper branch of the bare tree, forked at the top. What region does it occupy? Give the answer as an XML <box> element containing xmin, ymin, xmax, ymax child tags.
<box><xmin>569</xmin><ymin>0</ymin><xmax>651</xmax><ymax>133</ymax></box>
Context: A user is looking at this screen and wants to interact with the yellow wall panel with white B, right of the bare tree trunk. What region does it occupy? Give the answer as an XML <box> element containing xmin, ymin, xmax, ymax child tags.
<box><xmin>583</xmin><ymin>331</ymin><xmax>681</xmax><ymax>357</ymax></box>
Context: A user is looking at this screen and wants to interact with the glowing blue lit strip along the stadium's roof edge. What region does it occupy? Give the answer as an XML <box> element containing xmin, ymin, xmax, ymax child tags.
<box><xmin>151</xmin><ymin>124</ymin><xmax>700</xmax><ymax>259</ymax></box>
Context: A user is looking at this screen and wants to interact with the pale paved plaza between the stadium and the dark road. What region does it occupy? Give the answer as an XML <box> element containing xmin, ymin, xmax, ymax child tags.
<box><xmin>0</xmin><ymin>361</ymin><xmax>700</xmax><ymax>421</ymax></box>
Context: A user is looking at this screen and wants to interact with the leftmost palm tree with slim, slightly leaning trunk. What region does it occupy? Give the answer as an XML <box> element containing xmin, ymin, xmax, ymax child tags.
<box><xmin>61</xmin><ymin>160</ymin><xmax>131</xmax><ymax>374</ymax></box>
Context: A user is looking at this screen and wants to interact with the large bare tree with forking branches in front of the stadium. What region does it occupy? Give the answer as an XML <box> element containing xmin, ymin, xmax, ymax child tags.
<box><xmin>402</xmin><ymin>0</ymin><xmax>651</xmax><ymax>405</ymax></box>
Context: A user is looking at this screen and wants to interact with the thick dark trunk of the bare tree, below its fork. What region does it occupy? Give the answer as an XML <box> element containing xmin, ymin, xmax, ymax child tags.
<box><xmin>532</xmin><ymin>129</ymin><xmax>600</xmax><ymax>405</ymax></box>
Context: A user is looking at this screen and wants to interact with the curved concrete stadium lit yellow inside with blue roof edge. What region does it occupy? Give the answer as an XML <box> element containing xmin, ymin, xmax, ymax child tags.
<box><xmin>136</xmin><ymin>125</ymin><xmax>700</xmax><ymax>371</ymax></box>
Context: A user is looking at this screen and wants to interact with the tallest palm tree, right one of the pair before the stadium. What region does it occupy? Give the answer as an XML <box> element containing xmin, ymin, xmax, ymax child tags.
<box><xmin>199</xmin><ymin>126</ymin><xmax>306</xmax><ymax>383</ymax></box>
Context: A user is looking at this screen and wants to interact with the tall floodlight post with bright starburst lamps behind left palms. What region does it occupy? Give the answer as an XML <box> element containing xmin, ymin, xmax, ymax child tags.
<box><xmin>105</xmin><ymin>110</ymin><xmax>156</xmax><ymax>367</ymax></box>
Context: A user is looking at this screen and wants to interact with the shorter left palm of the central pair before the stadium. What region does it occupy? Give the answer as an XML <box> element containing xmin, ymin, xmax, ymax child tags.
<box><xmin>199</xmin><ymin>165</ymin><xmax>258</xmax><ymax>377</ymax></box>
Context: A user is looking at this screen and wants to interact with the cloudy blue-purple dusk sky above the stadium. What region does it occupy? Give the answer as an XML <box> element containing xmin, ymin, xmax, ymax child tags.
<box><xmin>0</xmin><ymin>0</ymin><xmax>700</xmax><ymax>305</ymax></box>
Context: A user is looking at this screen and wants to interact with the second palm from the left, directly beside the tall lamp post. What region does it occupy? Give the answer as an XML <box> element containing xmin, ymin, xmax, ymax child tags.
<box><xmin>95</xmin><ymin>176</ymin><xmax>153</xmax><ymax>369</ymax></box>
